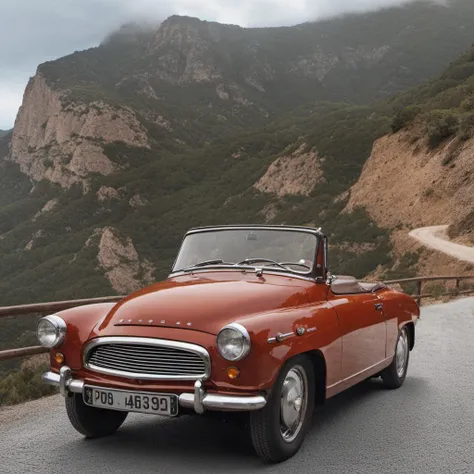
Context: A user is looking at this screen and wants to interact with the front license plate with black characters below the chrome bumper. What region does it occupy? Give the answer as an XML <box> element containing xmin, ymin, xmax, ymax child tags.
<box><xmin>83</xmin><ymin>385</ymin><xmax>178</xmax><ymax>416</ymax></box>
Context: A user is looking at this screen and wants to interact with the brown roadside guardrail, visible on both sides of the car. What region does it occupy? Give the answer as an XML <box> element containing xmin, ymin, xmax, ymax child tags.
<box><xmin>0</xmin><ymin>275</ymin><xmax>474</xmax><ymax>361</ymax></box>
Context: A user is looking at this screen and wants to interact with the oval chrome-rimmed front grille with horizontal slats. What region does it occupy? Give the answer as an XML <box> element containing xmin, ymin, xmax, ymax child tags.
<box><xmin>84</xmin><ymin>337</ymin><xmax>210</xmax><ymax>380</ymax></box>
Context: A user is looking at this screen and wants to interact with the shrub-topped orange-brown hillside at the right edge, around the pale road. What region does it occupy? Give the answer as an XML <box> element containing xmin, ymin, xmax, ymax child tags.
<box><xmin>346</xmin><ymin>47</ymin><xmax>474</xmax><ymax>274</ymax></box>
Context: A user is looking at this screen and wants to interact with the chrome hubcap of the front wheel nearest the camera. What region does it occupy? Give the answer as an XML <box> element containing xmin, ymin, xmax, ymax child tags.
<box><xmin>280</xmin><ymin>365</ymin><xmax>308</xmax><ymax>443</ymax></box>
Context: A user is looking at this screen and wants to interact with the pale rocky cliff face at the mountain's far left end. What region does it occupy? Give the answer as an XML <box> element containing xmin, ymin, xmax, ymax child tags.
<box><xmin>9</xmin><ymin>73</ymin><xmax>148</xmax><ymax>188</ymax></box>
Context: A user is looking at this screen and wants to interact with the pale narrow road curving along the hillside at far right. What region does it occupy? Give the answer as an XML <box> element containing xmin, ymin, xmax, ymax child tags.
<box><xmin>408</xmin><ymin>225</ymin><xmax>474</xmax><ymax>263</ymax></box>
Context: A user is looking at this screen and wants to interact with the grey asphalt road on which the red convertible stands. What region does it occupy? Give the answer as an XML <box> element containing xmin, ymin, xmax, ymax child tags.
<box><xmin>0</xmin><ymin>298</ymin><xmax>474</xmax><ymax>474</ymax></box>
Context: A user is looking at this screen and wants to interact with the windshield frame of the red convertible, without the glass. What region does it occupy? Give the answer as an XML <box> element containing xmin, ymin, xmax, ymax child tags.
<box><xmin>170</xmin><ymin>225</ymin><xmax>324</xmax><ymax>280</ymax></box>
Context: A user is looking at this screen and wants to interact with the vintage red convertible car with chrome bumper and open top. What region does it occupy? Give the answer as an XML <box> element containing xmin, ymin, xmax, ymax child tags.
<box><xmin>37</xmin><ymin>226</ymin><xmax>419</xmax><ymax>462</ymax></box>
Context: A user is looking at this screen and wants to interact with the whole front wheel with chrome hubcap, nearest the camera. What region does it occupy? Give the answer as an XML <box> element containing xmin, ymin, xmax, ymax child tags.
<box><xmin>250</xmin><ymin>356</ymin><xmax>315</xmax><ymax>463</ymax></box>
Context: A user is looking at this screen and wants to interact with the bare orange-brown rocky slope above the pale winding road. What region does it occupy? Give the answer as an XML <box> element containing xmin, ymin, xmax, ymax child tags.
<box><xmin>347</xmin><ymin>128</ymin><xmax>474</xmax><ymax>239</ymax></box>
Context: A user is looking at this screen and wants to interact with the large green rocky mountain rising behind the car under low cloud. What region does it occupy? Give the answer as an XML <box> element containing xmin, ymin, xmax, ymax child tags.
<box><xmin>0</xmin><ymin>0</ymin><xmax>474</xmax><ymax>312</ymax></box>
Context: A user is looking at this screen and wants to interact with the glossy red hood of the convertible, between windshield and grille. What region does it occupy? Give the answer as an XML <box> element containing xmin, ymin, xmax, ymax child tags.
<box><xmin>94</xmin><ymin>271</ymin><xmax>311</xmax><ymax>337</ymax></box>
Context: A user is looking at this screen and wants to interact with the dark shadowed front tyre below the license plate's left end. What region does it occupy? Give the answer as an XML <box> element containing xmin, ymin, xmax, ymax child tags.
<box><xmin>66</xmin><ymin>393</ymin><xmax>128</xmax><ymax>438</ymax></box>
